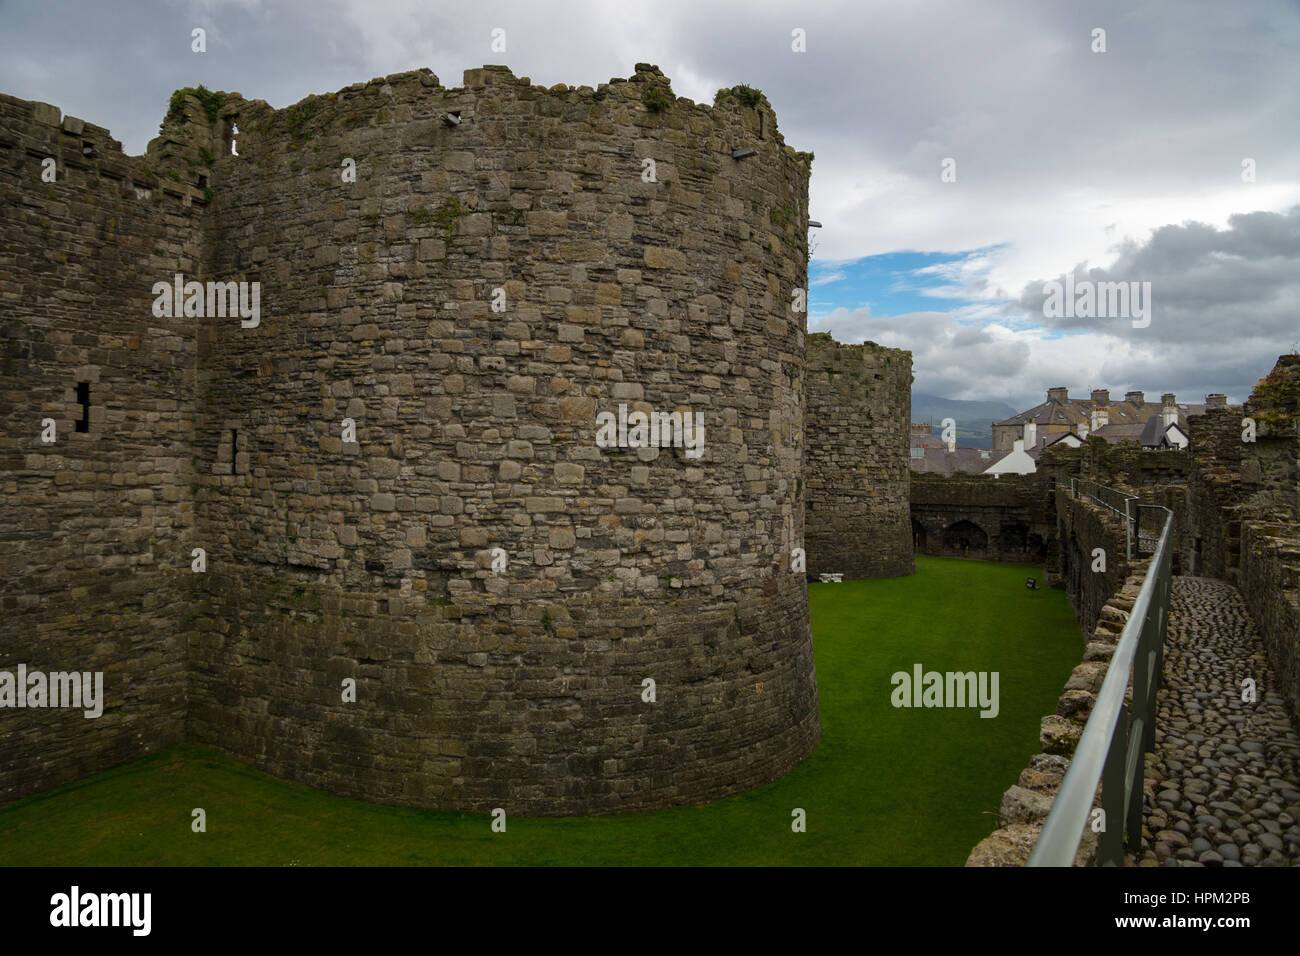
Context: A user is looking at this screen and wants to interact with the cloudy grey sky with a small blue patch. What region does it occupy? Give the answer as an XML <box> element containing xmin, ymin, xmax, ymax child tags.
<box><xmin>0</xmin><ymin>0</ymin><xmax>1300</xmax><ymax>408</ymax></box>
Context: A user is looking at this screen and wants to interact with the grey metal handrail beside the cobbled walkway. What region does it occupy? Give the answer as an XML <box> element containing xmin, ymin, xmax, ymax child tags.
<box><xmin>1028</xmin><ymin>496</ymin><xmax>1174</xmax><ymax>866</ymax></box>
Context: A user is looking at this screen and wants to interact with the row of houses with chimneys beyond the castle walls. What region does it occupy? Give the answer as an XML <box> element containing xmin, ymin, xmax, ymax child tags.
<box><xmin>910</xmin><ymin>388</ymin><xmax>1227</xmax><ymax>475</ymax></box>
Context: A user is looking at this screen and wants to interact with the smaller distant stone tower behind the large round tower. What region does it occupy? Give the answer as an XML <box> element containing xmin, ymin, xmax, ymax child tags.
<box><xmin>803</xmin><ymin>333</ymin><xmax>915</xmax><ymax>579</ymax></box>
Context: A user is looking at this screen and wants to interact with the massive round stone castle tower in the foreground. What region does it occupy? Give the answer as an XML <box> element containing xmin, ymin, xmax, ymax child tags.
<box><xmin>189</xmin><ymin>66</ymin><xmax>816</xmax><ymax>814</ymax></box>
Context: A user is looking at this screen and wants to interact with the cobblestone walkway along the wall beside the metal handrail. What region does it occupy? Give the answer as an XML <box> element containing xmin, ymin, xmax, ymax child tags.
<box><xmin>1136</xmin><ymin>578</ymin><xmax>1300</xmax><ymax>866</ymax></box>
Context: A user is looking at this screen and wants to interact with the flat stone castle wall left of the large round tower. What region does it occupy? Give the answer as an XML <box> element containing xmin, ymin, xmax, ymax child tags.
<box><xmin>0</xmin><ymin>95</ymin><xmax>202</xmax><ymax>803</ymax></box>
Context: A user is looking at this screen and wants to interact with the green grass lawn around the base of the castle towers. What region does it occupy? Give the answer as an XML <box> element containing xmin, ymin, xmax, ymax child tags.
<box><xmin>0</xmin><ymin>557</ymin><xmax>1082</xmax><ymax>866</ymax></box>
